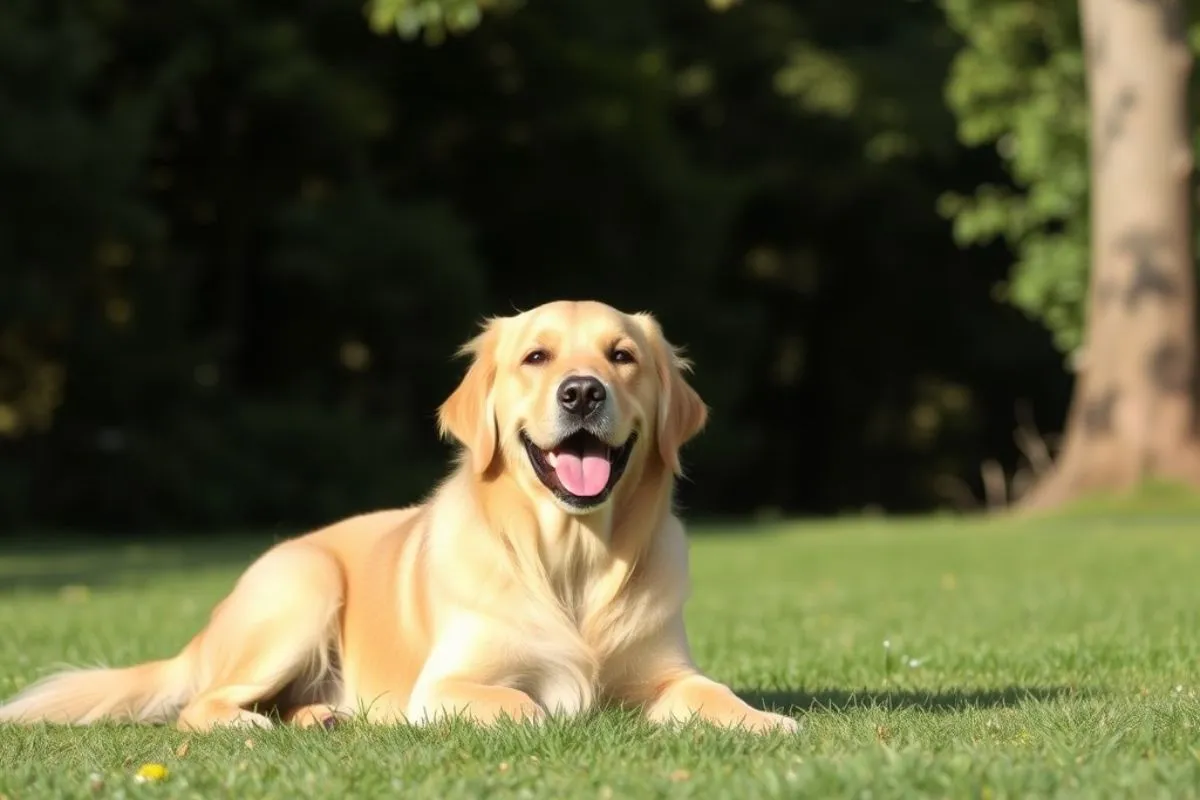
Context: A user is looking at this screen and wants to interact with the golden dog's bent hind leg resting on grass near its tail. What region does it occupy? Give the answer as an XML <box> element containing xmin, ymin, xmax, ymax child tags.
<box><xmin>179</xmin><ymin>540</ymin><xmax>343</xmax><ymax>730</ymax></box>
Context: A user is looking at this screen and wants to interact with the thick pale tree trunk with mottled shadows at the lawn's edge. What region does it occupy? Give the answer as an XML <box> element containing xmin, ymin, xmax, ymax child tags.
<box><xmin>1024</xmin><ymin>0</ymin><xmax>1200</xmax><ymax>507</ymax></box>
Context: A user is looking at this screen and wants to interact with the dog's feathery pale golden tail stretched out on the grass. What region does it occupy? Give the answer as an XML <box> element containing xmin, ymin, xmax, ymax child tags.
<box><xmin>0</xmin><ymin>657</ymin><xmax>192</xmax><ymax>724</ymax></box>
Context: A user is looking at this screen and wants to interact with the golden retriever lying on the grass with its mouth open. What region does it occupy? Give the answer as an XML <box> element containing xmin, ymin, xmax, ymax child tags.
<box><xmin>0</xmin><ymin>301</ymin><xmax>798</xmax><ymax>733</ymax></box>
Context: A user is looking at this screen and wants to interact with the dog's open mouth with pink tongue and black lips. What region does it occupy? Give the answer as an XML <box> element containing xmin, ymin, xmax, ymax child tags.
<box><xmin>521</xmin><ymin>431</ymin><xmax>637</xmax><ymax>509</ymax></box>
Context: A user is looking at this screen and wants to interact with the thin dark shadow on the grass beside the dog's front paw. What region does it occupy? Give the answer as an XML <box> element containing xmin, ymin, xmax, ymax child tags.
<box><xmin>737</xmin><ymin>686</ymin><xmax>1079</xmax><ymax>714</ymax></box>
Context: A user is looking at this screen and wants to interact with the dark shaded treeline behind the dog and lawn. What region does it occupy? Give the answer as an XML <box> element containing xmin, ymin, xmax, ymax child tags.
<box><xmin>0</xmin><ymin>0</ymin><xmax>1068</xmax><ymax>531</ymax></box>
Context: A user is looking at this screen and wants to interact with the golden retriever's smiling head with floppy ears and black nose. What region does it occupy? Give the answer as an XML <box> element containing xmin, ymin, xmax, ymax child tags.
<box><xmin>438</xmin><ymin>301</ymin><xmax>708</xmax><ymax>515</ymax></box>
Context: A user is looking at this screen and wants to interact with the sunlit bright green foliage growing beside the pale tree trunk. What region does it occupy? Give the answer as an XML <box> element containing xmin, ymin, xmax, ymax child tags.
<box><xmin>941</xmin><ymin>0</ymin><xmax>1200</xmax><ymax>355</ymax></box>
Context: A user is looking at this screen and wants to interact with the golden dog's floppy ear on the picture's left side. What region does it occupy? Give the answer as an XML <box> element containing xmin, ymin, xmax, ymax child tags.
<box><xmin>438</xmin><ymin>320</ymin><xmax>499</xmax><ymax>475</ymax></box>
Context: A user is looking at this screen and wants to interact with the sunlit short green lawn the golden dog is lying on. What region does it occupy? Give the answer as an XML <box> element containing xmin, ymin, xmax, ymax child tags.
<box><xmin>0</xmin><ymin>511</ymin><xmax>1200</xmax><ymax>800</ymax></box>
